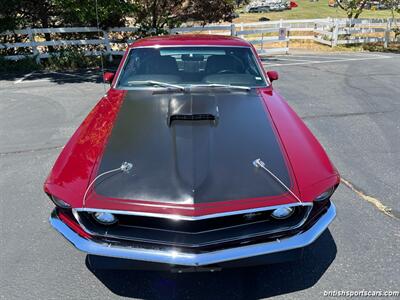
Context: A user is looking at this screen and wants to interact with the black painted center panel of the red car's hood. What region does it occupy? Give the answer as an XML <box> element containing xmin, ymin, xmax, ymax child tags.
<box><xmin>95</xmin><ymin>90</ymin><xmax>292</xmax><ymax>204</ymax></box>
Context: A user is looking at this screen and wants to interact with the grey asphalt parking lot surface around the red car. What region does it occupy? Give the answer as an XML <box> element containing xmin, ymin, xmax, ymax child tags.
<box><xmin>0</xmin><ymin>53</ymin><xmax>400</xmax><ymax>299</ymax></box>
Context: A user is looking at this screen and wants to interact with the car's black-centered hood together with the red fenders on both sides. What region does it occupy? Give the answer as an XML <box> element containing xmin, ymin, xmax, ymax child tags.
<box><xmin>45</xmin><ymin>88</ymin><xmax>339</xmax><ymax>216</ymax></box>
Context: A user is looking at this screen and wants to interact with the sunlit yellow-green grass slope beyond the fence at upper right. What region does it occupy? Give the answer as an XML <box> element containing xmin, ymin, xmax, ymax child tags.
<box><xmin>234</xmin><ymin>0</ymin><xmax>400</xmax><ymax>23</ymax></box>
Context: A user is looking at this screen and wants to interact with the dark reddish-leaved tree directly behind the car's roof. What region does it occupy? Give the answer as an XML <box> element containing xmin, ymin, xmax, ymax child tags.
<box><xmin>132</xmin><ymin>0</ymin><xmax>234</xmax><ymax>35</ymax></box>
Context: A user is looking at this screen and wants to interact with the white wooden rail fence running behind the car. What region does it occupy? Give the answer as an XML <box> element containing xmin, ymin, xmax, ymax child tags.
<box><xmin>0</xmin><ymin>18</ymin><xmax>400</xmax><ymax>62</ymax></box>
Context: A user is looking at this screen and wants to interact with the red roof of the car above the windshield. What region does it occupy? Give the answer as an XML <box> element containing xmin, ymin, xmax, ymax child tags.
<box><xmin>129</xmin><ymin>34</ymin><xmax>251</xmax><ymax>48</ymax></box>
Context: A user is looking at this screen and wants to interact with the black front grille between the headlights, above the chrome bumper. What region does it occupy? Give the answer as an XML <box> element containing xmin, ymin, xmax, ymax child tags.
<box><xmin>78</xmin><ymin>206</ymin><xmax>311</xmax><ymax>251</ymax></box>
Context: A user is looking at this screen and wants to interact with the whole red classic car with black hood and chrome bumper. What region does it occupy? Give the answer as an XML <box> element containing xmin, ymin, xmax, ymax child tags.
<box><xmin>44</xmin><ymin>35</ymin><xmax>339</xmax><ymax>270</ymax></box>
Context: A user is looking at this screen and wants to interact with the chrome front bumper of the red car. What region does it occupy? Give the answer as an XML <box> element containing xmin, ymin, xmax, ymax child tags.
<box><xmin>50</xmin><ymin>203</ymin><xmax>336</xmax><ymax>266</ymax></box>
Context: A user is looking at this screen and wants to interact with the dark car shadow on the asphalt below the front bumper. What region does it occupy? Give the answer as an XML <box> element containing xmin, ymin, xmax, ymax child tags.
<box><xmin>86</xmin><ymin>230</ymin><xmax>337</xmax><ymax>300</ymax></box>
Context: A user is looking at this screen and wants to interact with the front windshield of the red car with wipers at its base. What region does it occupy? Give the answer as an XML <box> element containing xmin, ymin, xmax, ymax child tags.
<box><xmin>117</xmin><ymin>47</ymin><xmax>266</xmax><ymax>89</ymax></box>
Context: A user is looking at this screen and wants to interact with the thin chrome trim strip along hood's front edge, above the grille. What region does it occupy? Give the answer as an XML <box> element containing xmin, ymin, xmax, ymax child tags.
<box><xmin>74</xmin><ymin>202</ymin><xmax>313</xmax><ymax>221</ymax></box>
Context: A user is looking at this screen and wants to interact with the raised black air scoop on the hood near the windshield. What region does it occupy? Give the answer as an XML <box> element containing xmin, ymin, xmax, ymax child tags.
<box><xmin>167</xmin><ymin>94</ymin><xmax>219</xmax><ymax>126</ymax></box>
